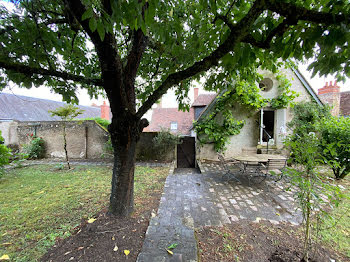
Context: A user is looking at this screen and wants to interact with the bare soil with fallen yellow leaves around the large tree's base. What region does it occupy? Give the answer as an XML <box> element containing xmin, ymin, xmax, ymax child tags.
<box><xmin>41</xmin><ymin>191</ymin><xmax>161</xmax><ymax>262</ymax></box>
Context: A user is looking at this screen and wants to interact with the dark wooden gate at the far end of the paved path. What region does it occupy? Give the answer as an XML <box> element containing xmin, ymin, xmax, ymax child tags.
<box><xmin>177</xmin><ymin>136</ymin><xmax>196</xmax><ymax>168</ymax></box>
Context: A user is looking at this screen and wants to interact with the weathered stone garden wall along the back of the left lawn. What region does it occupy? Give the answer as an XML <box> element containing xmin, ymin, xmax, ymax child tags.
<box><xmin>15</xmin><ymin>120</ymin><xmax>175</xmax><ymax>162</ymax></box>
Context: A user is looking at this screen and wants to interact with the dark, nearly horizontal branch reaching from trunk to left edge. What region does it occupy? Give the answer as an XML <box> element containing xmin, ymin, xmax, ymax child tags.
<box><xmin>0</xmin><ymin>61</ymin><xmax>103</xmax><ymax>86</ymax></box>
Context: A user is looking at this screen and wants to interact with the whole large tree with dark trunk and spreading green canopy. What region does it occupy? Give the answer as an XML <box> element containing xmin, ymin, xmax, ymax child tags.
<box><xmin>0</xmin><ymin>0</ymin><xmax>350</xmax><ymax>215</ymax></box>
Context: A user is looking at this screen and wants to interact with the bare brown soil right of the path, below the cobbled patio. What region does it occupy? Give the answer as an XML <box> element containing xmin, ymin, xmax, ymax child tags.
<box><xmin>196</xmin><ymin>220</ymin><xmax>348</xmax><ymax>262</ymax></box>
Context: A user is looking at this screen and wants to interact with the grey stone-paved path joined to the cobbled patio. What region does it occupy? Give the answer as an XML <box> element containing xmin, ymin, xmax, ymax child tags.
<box><xmin>137</xmin><ymin>163</ymin><xmax>301</xmax><ymax>262</ymax></box>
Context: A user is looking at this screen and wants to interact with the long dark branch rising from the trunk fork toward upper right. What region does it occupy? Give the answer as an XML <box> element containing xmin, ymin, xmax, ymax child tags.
<box><xmin>136</xmin><ymin>0</ymin><xmax>265</xmax><ymax>118</ymax></box>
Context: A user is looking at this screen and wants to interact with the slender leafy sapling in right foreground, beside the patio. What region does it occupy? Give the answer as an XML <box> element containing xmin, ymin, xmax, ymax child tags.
<box><xmin>285</xmin><ymin>133</ymin><xmax>343</xmax><ymax>261</ymax></box>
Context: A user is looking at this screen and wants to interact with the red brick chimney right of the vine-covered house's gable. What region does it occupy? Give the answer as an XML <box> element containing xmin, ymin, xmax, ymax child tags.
<box><xmin>318</xmin><ymin>81</ymin><xmax>340</xmax><ymax>116</ymax></box>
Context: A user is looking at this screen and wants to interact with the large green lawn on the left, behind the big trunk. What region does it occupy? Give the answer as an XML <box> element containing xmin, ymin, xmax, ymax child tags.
<box><xmin>0</xmin><ymin>165</ymin><xmax>168</xmax><ymax>261</ymax></box>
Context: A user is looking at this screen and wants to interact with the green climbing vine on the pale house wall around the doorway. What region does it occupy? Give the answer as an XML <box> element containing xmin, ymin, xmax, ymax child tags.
<box><xmin>194</xmin><ymin>73</ymin><xmax>298</xmax><ymax>152</ymax></box>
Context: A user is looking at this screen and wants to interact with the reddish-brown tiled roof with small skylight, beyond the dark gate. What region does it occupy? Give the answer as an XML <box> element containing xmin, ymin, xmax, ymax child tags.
<box><xmin>144</xmin><ymin>107</ymin><xmax>194</xmax><ymax>135</ymax></box>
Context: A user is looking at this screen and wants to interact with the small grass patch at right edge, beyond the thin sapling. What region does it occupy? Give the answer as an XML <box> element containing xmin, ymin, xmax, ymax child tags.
<box><xmin>320</xmin><ymin>176</ymin><xmax>350</xmax><ymax>259</ymax></box>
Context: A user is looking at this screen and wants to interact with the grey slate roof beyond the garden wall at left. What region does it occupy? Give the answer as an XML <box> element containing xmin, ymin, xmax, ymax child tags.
<box><xmin>0</xmin><ymin>93</ymin><xmax>101</xmax><ymax>121</ymax></box>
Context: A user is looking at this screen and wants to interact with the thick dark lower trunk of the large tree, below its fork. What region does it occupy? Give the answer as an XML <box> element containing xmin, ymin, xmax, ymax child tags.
<box><xmin>109</xmin><ymin>114</ymin><xmax>148</xmax><ymax>217</ymax></box>
